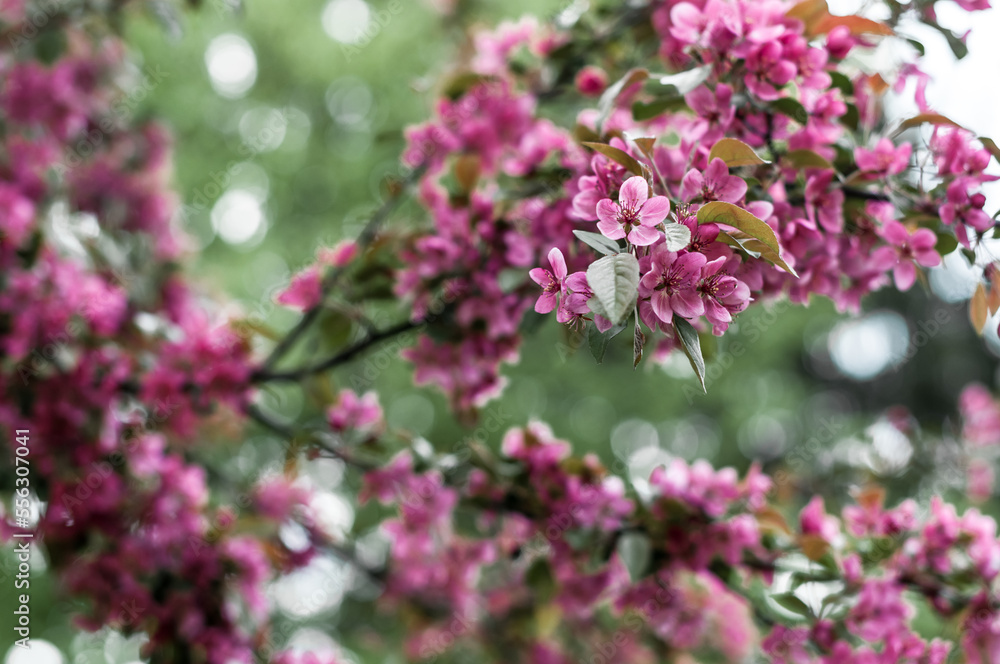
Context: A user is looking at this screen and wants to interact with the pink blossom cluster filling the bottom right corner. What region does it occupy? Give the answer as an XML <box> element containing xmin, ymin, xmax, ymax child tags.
<box><xmin>762</xmin><ymin>491</ymin><xmax>1000</xmax><ymax>664</ymax></box>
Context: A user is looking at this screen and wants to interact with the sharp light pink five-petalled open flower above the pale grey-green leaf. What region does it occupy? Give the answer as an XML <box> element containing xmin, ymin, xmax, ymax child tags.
<box><xmin>597</xmin><ymin>175</ymin><xmax>670</xmax><ymax>247</ymax></box>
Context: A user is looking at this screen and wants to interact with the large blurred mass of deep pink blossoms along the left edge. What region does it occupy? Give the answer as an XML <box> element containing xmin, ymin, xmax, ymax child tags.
<box><xmin>0</xmin><ymin>15</ymin><xmax>320</xmax><ymax>663</ymax></box>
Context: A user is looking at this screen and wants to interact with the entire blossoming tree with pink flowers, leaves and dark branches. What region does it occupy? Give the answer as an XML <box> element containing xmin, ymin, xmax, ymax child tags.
<box><xmin>0</xmin><ymin>0</ymin><xmax>1000</xmax><ymax>664</ymax></box>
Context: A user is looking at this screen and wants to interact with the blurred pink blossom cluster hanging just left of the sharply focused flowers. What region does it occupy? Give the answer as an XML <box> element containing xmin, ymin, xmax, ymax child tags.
<box><xmin>388</xmin><ymin>72</ymin><xmax>582</xmax><ymax>410</ymax></box>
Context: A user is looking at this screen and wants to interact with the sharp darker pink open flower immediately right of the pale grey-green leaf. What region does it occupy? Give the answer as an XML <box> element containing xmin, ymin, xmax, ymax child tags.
<box><xmin>639</xmin><ymin>245</ymin><xmax>707</xmax><ymax>323</ymax></box>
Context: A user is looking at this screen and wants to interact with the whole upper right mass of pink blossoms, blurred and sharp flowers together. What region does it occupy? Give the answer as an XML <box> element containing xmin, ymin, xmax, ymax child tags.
<box><xmin>344</xmin><ymin>0</ymin><xmax>993</xmax><ymax>411</ymax></box>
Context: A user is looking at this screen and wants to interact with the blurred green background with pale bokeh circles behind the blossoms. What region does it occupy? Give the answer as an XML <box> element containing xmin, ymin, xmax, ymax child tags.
<box><xmin>0</xmin><ymin>0</ymin><xmax>1000</xmax><ymax>664</ymax></box>
